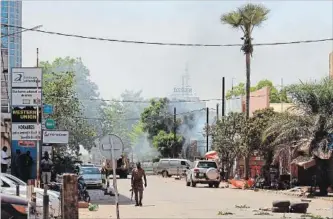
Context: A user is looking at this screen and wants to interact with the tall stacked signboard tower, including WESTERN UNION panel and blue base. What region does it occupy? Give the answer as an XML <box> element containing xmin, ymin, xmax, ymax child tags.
<box><xmin>9</xmin><ymin>67</ymin><xmax>43</xmax><ymax>179</ymax></box>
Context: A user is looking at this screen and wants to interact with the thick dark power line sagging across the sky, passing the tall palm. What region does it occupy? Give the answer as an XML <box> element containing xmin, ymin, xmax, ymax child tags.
<box><xmin>1</xmin><ymin>24</ymin><xmax>333</xmax><ymax>47</ymax></box>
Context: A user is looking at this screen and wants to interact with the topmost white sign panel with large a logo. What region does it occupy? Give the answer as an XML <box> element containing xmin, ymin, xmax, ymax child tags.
<box><xmin>12</xmin><ymin>68</ymin><xmax>42</xmax><ymax>88</ymax></box>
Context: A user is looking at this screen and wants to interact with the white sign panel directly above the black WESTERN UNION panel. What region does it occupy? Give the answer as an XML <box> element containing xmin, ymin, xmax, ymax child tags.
<box><xmin>12</xmin><ymin>88</ymin><xmax>42</xmax><ymax>106</ymax></box>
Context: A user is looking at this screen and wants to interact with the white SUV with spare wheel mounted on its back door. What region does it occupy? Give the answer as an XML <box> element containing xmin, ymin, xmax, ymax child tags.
<box><xmin>186</xmin><ymin>160</ymin><xmax>221</xmax><ymax>188</ymax></box>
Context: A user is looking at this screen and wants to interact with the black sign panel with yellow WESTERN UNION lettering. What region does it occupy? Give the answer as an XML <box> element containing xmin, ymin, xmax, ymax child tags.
<box><xmin>12</xmin><ymin>106</ymin><xmax>42</xmax><ymax>123</ymax></box>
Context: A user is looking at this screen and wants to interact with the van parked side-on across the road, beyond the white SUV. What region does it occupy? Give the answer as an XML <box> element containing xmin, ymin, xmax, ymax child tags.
<box><xmin>156</xmin><ymin>158</ymin><xmax>192</xmax><ymax>177</ymax></box>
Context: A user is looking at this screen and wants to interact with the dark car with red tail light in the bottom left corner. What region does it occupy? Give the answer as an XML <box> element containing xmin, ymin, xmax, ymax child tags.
<box><xmin>1</xmin><ymin>194</ymin><xmax>29</xmax><ymax>219</ymax></box>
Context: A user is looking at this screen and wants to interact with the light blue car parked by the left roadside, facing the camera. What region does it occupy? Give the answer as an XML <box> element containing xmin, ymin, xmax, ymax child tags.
<box><xmin>80</xmin><ymin>166</ymin><xmax>103</xmax><ymax>189</ymax></box>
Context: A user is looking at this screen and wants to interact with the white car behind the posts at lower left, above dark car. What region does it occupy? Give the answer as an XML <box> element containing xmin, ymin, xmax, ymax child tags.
<box><xmin>0</xmin><ymin>173</ymin><xmax>61</xmax><ymax>217</ymax></box>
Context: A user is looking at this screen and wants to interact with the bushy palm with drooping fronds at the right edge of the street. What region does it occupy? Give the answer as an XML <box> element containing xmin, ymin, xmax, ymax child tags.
<box><xmin>263</xmin><ymin>78</ymin><xmax>333</xmax><ymax>195</ymax></box>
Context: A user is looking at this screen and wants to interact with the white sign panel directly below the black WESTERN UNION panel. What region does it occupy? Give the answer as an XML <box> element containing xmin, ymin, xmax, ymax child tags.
<box><xmin>12</xmin><ymin>123</ymin><xmax>41</xmax><ymax>141</ymax></box>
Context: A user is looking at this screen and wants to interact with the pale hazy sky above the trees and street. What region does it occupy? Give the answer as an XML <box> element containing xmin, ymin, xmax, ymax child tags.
<box><xmin>23</xmin><ymin>1</ymin><xmax>333</xmax><ymax>102</ymax></box>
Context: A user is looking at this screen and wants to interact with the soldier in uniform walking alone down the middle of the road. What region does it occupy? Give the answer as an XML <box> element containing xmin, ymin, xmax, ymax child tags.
<box><xmin>131</xmin><ymin>162</ymin><xmax>147</xmax><ymax>206</ymax></box>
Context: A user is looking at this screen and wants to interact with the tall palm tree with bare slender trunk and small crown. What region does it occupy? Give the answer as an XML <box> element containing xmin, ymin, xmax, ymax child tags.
<box><xmin>221</xmin><ymin>3</ymin><xmax>269</xmax><ymax>178</ymax></box>
